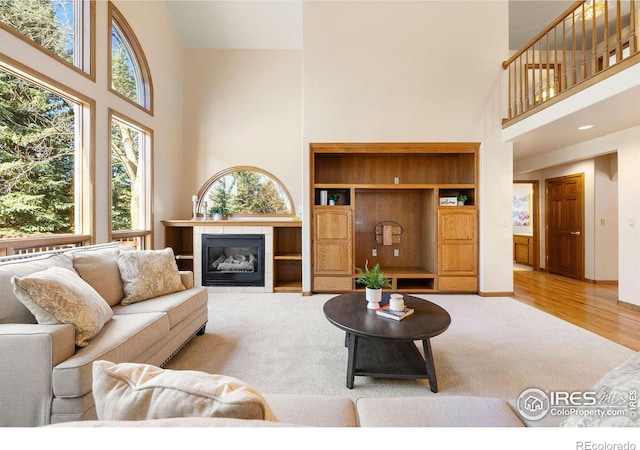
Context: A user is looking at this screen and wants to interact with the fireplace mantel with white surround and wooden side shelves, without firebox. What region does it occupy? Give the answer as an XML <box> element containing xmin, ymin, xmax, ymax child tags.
<box><xmin>162</xmin><ymin>217</ymin><xmax>302</xmax><ymax>292</ymax></box>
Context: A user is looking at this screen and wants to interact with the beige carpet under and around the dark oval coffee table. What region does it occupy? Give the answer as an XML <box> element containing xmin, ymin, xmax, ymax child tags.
<box><xmin>166</xmin><ymin>294</ymin><xmax>634</xmax><ymax>400</ymax></box>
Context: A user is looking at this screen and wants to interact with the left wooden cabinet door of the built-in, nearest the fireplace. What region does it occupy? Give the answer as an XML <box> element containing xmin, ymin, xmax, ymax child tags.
<box><xmin>313</xmin><ymin>207</ymin><xmax>353</xmax><ymax>276</ymax></box>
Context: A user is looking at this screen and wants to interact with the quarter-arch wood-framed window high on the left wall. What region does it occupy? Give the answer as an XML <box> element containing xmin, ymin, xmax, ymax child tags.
<box><xmin>109</xmin><ymin>3</ymin><xmax>153</xmax><ymax>112</ymax></box>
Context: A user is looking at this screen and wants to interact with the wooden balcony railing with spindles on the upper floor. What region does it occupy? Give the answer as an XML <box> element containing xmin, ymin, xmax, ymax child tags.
<box><xmin>502</xmin><ymin>0</ymin><xmax>640</xmax><ymax>126</ymax></box>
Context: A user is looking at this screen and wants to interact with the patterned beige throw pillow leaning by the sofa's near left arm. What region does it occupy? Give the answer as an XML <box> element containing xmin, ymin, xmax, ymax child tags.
<box><xmin>11</xmin><ymin>267</ymin><xmax>113</xmax><ymax>347</ymax></box>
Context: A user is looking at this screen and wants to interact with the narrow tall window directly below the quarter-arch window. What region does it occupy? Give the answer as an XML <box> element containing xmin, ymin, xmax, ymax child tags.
<box><xmin>111</xmin><ymin>116</ymin><xmax>151</xmax><ymax>243</ymax></box>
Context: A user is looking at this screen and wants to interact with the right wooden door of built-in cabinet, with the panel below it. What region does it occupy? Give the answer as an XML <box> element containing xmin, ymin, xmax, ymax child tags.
<box><xmin>438</xmin><ymin>208</ymin><xmax>478</xmax><ymax>291</ymax></box>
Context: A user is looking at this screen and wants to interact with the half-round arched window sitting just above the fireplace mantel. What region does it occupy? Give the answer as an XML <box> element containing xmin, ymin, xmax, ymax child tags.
<box><xmin>198</xmin><ymin>167</ymin><xmax>293</xmax><ymax>216</ymax></box>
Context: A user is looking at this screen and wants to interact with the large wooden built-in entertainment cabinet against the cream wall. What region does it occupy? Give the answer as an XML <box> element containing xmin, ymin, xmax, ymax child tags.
<box><xmin>310</xmin><ymin>143</ymin><xmax>479</xmax><ymax>293</ymax></box>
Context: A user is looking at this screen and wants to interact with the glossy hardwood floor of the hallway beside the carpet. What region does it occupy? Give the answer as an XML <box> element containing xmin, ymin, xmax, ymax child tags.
<box><xmin>513</xmin><ymin>270</ymin><xmax>640</xmax><ymax>351</ymax></box>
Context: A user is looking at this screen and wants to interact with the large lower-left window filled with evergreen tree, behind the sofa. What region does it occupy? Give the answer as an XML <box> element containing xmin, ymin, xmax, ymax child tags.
<box><xmin>0</xmin><ymin>67</ymin><xmax>82</xmax><ymax>238</ymax></box>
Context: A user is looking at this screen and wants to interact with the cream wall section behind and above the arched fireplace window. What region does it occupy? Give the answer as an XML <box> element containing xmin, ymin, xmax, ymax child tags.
<box><xmin>182</xmin><ymin>49</ymin><xmax>302</xmax><ymax>217</ymax></box>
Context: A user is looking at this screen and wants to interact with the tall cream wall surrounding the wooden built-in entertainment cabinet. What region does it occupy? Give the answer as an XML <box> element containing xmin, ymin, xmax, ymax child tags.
<box><xmin>303</xmin><ymin>1</ymin><xmax>513</xmax><ymax>293</ymax></box>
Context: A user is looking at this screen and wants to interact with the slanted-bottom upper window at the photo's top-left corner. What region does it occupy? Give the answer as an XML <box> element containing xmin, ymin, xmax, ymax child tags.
<box><xmin>0</xmin><ymin>0</ymin><xmax>93</xmax><ymax>74</ymax></box>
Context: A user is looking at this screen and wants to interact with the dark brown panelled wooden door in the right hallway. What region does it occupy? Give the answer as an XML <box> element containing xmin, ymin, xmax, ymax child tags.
<box><xmin>546</xmin><ymin>174</ymin><xmax>584</xmax><ymax>280</ymax></box>
